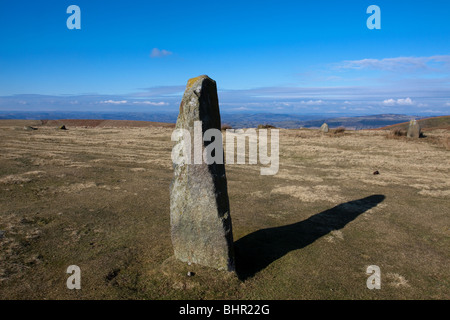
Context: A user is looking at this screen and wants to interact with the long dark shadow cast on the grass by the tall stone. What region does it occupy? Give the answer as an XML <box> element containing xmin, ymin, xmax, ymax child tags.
<box><xmin>234</xmin><ymin>195</ymin><xmax>385</xmax><ymax>280</ymax></box>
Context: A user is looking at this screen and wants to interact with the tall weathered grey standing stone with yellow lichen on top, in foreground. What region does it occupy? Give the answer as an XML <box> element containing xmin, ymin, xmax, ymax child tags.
<box><xmin>170</xmin><ymin>76</ymin><xmax>235</xmax><ymax>271</ymax></box>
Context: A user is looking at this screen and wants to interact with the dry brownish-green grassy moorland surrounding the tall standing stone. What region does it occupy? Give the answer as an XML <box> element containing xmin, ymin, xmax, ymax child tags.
<box><xmin>0</xmin><ymin>121</ymin><xmax>450</xmax><ymax>299</ymax></box>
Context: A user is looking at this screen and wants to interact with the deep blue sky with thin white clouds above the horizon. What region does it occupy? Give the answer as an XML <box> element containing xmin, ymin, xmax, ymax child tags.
<box><xmin>0</xmin><ymin>0</ymin><xmax>450</xmax><ymax>115</ymax></box>
